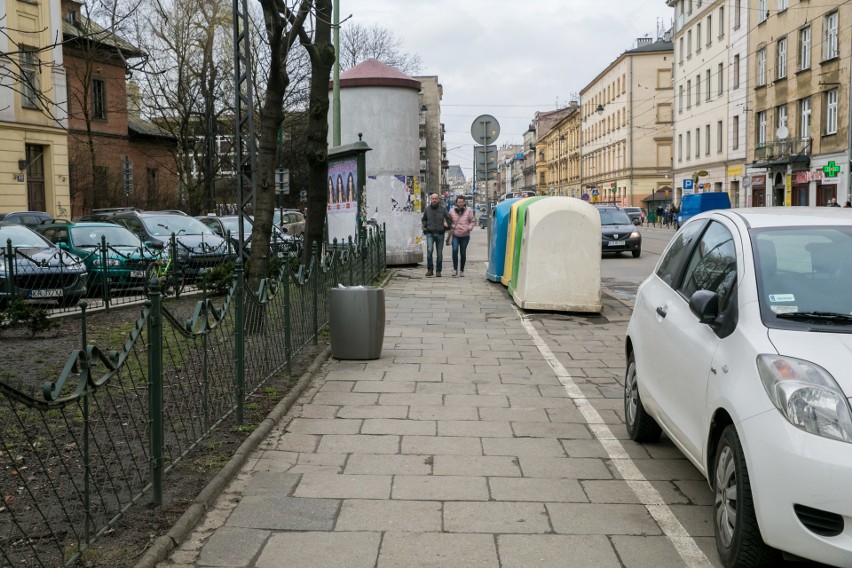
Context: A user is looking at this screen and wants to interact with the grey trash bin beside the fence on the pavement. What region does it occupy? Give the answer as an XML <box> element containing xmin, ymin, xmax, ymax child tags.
<box><xmin>328</xmin><ymin>286</ymin><xmax>385</xmax><ymax>359</ymax></box>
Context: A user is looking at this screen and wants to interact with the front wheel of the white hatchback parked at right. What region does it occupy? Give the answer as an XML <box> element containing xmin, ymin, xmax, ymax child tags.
<box><xmin>713</xmin><ymin>425</ymin><xmax>778</xmax><ymax>566</ymax></box>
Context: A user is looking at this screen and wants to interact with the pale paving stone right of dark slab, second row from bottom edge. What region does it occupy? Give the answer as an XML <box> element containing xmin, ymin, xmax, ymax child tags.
<box><xmin>335</xmin><ymin>499</ymin><xmax>442</xmax><ymax>532</ymax></box>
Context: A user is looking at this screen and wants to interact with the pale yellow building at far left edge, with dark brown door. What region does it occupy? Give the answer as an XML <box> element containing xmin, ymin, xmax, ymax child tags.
<box><xmin>0</xmin><ymin>0</ymin><xmax>70</xmax><ymax>217</ymax></box>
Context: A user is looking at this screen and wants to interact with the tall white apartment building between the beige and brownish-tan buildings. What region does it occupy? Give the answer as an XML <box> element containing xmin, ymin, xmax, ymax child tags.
<box><xmin>669</xmin><ymin>0</ymin><xmax>742</xmax><ymax>202</ymax></box>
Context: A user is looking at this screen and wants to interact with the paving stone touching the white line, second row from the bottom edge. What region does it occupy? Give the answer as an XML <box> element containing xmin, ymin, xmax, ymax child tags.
<box><xmin>547</xmin><ymin>503</ymin><xmax>661</xmax><ymax>535</ymax></box>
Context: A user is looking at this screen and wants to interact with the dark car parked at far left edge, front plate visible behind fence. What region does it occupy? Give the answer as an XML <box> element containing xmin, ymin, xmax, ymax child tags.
<box><xmin>0</xmin><ymin>222</ymin><xmax>88</xmax><ymax>306</ymax></box>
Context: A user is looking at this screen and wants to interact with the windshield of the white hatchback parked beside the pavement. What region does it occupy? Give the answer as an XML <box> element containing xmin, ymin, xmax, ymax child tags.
<box><xmin>751</xmin><ymin>226</ymin><xmax>852</xmax><ymax>328</ymax></box>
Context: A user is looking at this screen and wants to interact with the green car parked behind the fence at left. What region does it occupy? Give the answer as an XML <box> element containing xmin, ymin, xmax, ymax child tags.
<box><xmin>35</xmin><ymin>221</ymin><xmax>168</xmax><ymax>289</ymax></box>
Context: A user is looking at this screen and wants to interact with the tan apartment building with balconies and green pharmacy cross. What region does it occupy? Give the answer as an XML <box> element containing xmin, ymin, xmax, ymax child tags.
<box><xmin>745</xmin><ymin>0</ymin><xmax>852</xmax><ymax>206</ymax></box>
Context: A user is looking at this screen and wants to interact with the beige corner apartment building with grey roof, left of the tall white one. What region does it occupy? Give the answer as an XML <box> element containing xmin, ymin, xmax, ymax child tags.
<box><xmin>579</xmin><ymin>38</ymin><xmax>673</xmax><ymax>206</ymax></box>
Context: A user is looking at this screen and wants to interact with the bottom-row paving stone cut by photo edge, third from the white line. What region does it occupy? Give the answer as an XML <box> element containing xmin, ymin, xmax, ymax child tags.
<box><xmin>377</xmin><ymin>532</ymin><xmax>500</xmax><ymax>568</ymax></box>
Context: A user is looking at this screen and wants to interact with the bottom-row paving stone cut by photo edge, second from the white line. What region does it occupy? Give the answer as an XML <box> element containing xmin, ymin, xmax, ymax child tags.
<box><xmin>497</xmin><ymin>534</ymin><xmax>620</xmax><ymax>568</ymax></box>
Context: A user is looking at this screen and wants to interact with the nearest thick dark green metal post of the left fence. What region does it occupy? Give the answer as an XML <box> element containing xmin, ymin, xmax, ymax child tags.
<box><xmin>148</xmin><ymin>280</ymin><xmax>164</xmax><ymax>507</ymax></box>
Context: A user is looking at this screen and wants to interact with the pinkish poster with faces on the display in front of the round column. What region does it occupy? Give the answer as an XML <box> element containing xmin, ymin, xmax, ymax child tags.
<box><xmin>326</xmin><ymin>158</ymin><xmax>358</xmax><ymax>243</ymax></box>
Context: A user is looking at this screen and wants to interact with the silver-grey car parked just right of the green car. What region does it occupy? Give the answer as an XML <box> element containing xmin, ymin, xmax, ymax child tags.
<box><xmin>82</xmin><ymin>209</ymin><xmax>231</xmax><ymax>280</ymax></box>
